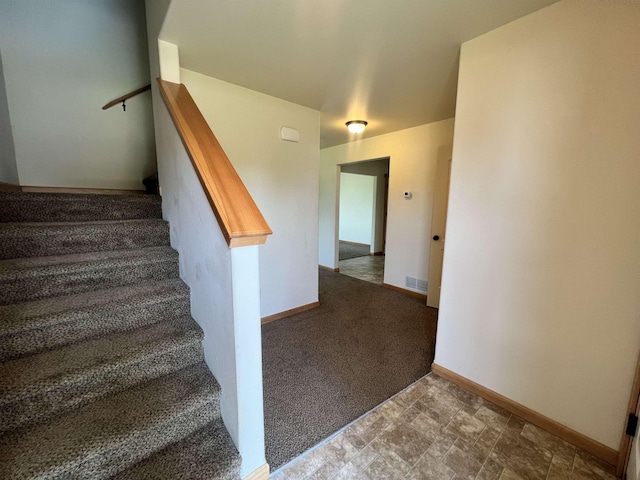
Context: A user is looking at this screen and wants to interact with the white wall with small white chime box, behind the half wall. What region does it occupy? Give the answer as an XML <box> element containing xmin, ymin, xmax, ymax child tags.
<box><xmin>181</xmin><ymin>69</ymin><xmax>320</xmax><ymax>317</ymax></box>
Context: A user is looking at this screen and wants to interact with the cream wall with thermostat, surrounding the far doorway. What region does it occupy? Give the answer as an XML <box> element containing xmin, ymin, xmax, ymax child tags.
<box><xmin>319</xmin><ymin>119</ymin><xmax>453</xmax><ymax>291</ymax></box>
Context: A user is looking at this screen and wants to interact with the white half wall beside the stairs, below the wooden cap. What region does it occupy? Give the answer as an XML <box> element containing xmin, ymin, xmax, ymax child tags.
<box><xmin>155</xmin><ymin>98</ymin><xmax>266</xmax><ymax>477</ymax></box>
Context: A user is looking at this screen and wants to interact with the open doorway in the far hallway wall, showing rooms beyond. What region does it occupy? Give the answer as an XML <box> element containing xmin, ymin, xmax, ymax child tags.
<box><xmin>336</xmin><ymin>157</ymin><xmax>389</xmax><ymax>285</ymax></box>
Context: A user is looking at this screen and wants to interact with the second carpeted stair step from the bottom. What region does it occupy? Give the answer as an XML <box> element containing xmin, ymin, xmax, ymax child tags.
<box><xmin>0</xmin><ymin>363</ymin><xmax>220</xmax><ymax>479</ymax></box>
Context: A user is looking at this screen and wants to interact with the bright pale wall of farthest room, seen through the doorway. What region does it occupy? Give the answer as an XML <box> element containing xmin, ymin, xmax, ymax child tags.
<box><xmin>339</xmin><ymin>173</ymin><xmax>376</xmax><ymax>246</ymax></box>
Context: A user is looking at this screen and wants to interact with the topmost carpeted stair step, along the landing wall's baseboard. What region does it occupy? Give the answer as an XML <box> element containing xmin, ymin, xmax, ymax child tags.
<box><xmin>0</xmin><ymin>192</ymin><xmax>162</xmax><ymax>222</ymax></box>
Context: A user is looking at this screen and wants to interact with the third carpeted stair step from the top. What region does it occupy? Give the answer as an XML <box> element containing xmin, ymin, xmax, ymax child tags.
<box><xmin>0</xmin><ymin>246</ymin><xmax>179</xmax><ymax>305</ymax></box>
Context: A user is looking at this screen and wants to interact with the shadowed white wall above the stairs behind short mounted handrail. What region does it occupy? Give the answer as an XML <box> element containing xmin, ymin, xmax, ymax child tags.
<box><xmin>0</xmin><ymin>0</ymin><xmax>156</xmax><ymax>189</ymax></box>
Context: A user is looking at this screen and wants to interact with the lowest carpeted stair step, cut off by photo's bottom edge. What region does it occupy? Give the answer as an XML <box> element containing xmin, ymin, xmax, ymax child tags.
<box><xmin>112</xmin><ymin>419</ymin><xmax>240</xmax><ymax>480</ymax></box>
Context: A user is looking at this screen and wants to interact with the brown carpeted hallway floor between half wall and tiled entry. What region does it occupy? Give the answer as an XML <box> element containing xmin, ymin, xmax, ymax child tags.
<box><xmin>262</xmin><ymin>270</ymin><xmax>437</xmax><ymax>471</ymax></box>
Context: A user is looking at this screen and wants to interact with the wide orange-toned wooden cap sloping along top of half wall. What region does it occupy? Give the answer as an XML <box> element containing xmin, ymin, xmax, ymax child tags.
<box><xmin>158</xmin><ymin>79</ymin><xmax>273</xmax><ymax>248</ymax></box>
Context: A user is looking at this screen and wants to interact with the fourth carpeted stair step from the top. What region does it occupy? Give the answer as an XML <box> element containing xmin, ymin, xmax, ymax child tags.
<box><xmin>0</xmin><ymin>279</ymin><xmax>190</xmax><ymax>361</ymax></box>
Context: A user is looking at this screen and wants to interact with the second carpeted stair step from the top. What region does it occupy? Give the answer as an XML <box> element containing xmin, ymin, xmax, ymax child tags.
<box><xmin>0</xmin><ymin>219</ymin><xmax>169</xmax><ymax>259</ymax></box>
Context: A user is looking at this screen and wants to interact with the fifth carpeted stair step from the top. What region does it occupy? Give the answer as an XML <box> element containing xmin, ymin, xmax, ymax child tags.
<box><xmin>0</xmin><ymin>317</ymin><xmax>203</xmax><ymax>432</ymax></box>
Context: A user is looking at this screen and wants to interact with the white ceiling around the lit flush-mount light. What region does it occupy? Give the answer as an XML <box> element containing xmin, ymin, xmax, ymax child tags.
<box><xmin>160</xmin><ymin>0</ymin><xmax>557</xmax><ymax>148</ymax></box>
